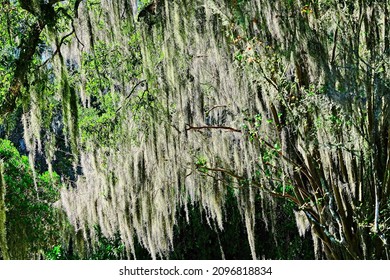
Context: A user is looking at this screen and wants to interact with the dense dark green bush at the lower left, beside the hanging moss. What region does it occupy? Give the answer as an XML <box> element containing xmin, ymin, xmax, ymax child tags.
<box><xmin>0</xmin><ymin>139</ymin><xmax>60</xmax><ymax>259</ymax></box>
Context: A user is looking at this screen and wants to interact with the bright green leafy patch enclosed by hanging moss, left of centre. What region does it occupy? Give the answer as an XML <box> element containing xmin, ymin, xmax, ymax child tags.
<box><xmin>77</xmin><ymin>27</ymin><xmax>144</xmax><ymax>146</ymax></box>
